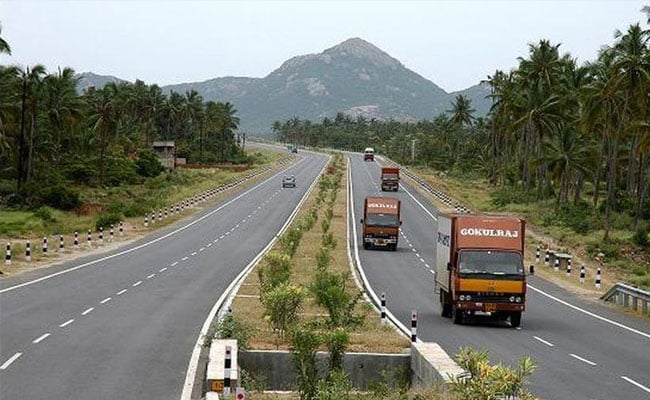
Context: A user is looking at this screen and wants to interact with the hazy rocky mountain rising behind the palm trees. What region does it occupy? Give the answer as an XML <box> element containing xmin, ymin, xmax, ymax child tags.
<box><xmin>76</xmin><ymin>38</ymin><xmax>490</xmax><ymax>133</ymax></box>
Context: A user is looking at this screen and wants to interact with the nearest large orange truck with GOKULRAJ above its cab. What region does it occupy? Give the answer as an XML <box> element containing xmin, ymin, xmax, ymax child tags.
<box><xmin>433</xmin><ymin>213</ymin><xmax>526</xmax><ymax>328</ymax></box>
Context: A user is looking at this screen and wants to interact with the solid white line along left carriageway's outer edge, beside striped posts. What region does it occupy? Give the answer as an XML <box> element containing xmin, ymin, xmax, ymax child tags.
<box><xmin>0</xmin><ymin>158</ymin><xmax>306</xmax><ymax>294</ymax></box>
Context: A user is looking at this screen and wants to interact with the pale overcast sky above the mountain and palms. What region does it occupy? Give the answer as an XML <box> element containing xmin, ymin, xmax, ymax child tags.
<box><xmin>0</xmin><ymin>0</ymin><xmax>650</xmax><ymax>92</ymax></box>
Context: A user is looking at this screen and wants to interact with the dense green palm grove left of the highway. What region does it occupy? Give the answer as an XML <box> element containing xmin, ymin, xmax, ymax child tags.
<box><xmin>0</xmin><ymin>27</ymin><xmax>246</xmax><ymax>216</ymax></box>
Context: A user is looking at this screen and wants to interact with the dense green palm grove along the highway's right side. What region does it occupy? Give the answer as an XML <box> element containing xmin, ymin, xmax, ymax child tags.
<box><xmin>273</xmin><ymin>13</ymin><xmax>650</xmax><ymax>283</ymax></box>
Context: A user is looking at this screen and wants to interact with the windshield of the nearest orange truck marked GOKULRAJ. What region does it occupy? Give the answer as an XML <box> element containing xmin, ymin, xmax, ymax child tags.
<box><xmin>459</xmin><ymin>250</ymin><xmax>524</xmax><ymax>275</ymax></box>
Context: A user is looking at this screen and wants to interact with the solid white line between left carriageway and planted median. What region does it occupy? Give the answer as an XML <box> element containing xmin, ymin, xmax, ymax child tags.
<box><xmin>181</xmin><ymin>152</ymin><xmax>331</xmax><ymax>400</ymax></box>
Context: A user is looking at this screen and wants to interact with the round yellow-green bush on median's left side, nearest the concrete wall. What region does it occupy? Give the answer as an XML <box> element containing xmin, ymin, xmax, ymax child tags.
<box><xmin>260</xmin><ymin>283</ymin><xmax>305</xmax><ymax>337</ymax></box>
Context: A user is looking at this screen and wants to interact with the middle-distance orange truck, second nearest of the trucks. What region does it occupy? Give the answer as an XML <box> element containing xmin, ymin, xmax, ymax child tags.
<box><xmin>361</xmin><ymin>196</ymin><xmax>402</xmax><ymax>251</ymax></box>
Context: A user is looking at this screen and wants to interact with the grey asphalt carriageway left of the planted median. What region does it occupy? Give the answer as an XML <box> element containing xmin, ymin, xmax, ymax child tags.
<box><xmin>0</xmin><ymin>152</ymin><xmax>326</xmax><ymax>400</ymax></box>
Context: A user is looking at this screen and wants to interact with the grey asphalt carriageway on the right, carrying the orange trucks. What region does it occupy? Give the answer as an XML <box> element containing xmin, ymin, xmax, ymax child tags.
<box><xmin>350</xmin><ymin>155</ymin><xmax>650</xmax><ymax>400</ymax></box>
